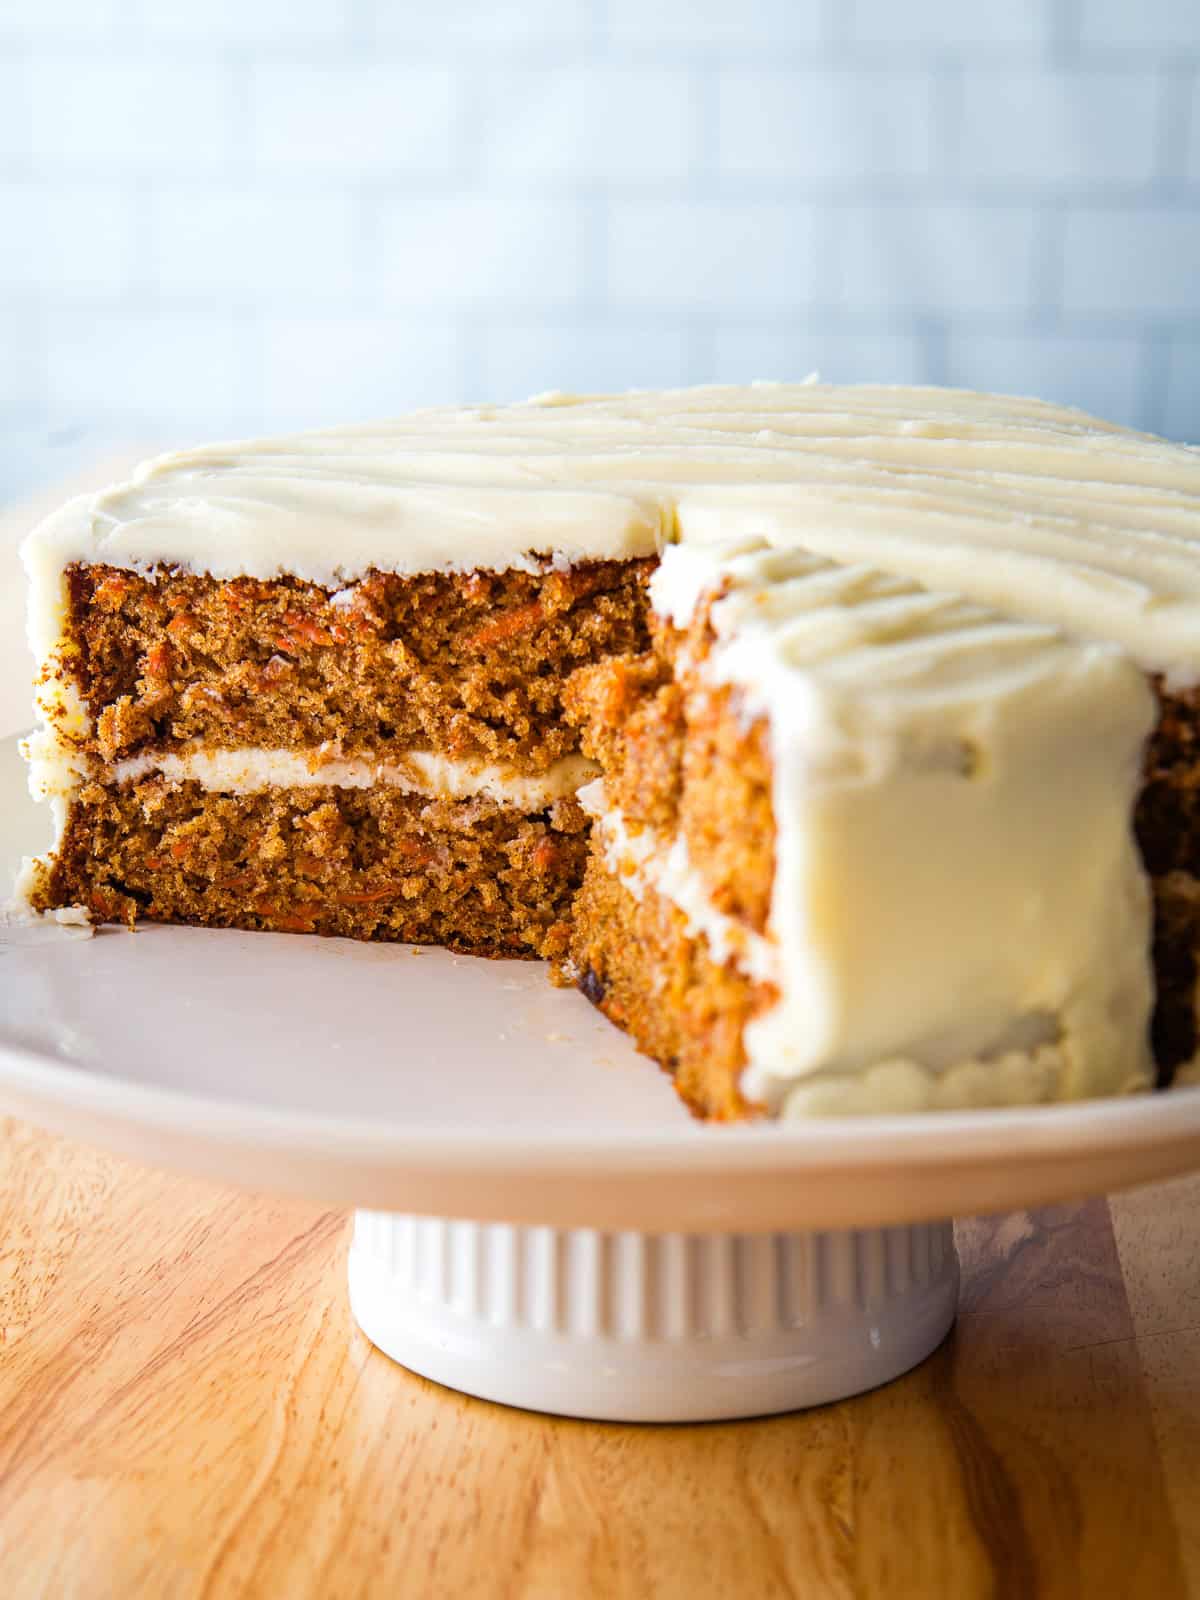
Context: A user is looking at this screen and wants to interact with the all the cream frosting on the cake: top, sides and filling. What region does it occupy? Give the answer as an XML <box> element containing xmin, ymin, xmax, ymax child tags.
<box><xmin>22</xmin><ymin>382</ymin><xmax>1200</xmax><ymax>1112</ymax></box>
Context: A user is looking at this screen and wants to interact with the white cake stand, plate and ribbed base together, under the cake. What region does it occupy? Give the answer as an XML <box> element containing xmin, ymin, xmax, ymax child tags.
<box><xmin>0</xmin><ymin>739</ymin><xmax>1200</xmax><ymax>1421</ymax></box>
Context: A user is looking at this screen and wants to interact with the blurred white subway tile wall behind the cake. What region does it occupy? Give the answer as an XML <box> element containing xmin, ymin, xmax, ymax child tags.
<box><xmin>0</xmin><ymin>0</ymin><xmax>1200</xmax><ymax>501</ymax></box>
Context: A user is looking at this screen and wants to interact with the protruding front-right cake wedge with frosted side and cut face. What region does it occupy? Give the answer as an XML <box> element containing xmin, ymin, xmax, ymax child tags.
<box><xmin>568</xmin><ymin>541</ymin><xmax>1154</xmax><ymax>1117</ymax></box>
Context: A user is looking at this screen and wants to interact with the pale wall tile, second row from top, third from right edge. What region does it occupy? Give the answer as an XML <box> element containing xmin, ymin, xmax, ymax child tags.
<box><xmin>717</xmin><ymin>67</ymin><xmax>933</xmax><ymax>178</ymax></box>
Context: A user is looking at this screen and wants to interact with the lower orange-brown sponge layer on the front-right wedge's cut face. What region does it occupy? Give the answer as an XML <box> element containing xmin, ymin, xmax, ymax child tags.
<box><xmin>565</xmin><ymin>854</ymin><xmax>776</xmax><ymax>1122</ymax></box>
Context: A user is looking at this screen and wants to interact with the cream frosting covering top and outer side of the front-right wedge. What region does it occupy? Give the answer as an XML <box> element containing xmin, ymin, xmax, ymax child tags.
<box><xmin>649</xmin><ymin>541</ymin><xmax>1155</xmax><ymax>1110</ymax></box>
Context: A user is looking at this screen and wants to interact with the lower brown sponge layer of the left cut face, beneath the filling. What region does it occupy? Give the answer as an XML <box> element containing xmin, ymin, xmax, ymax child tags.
<box><xmin>34</xmin><ymin>778</ymin><xmax>587</xmax><ymax>957</ymax></box>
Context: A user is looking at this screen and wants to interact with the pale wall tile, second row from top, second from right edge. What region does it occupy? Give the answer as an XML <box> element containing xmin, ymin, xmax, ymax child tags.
<box><xmin>947</xmin><ymin>66</ymin><xmax>1158</xmax><ymax>182</ymax></box>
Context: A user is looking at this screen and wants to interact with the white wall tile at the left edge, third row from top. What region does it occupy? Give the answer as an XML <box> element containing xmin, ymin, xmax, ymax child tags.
<box><xmin>0</xmin><ymin>182</ymin><xmax>136</xmax><ymax>296</ymax></box>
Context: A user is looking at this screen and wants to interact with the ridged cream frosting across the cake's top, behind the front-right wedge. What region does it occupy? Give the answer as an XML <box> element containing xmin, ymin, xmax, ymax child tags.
<box><xmin>27</xmin><ymin>382</ymin><xmax>1200</xmax><ymax>680</ymax></box>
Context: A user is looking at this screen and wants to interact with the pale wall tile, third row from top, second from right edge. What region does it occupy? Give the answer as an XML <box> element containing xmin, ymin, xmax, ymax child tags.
<box><xmin>830</xmin><ymin>205</ymin><xmax>1034</xmax><ymax>315</ymax></box>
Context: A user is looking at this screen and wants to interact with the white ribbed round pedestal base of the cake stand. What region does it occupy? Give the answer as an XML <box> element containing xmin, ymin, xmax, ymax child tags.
<box><xmin>350</xmin><ymin>1211</ymin><xmax>958</xmax><ymax>1422</ymax></box>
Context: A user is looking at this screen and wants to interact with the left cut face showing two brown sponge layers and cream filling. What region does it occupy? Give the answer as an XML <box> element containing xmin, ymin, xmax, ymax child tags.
<box><xmin>21</xmin><ymin>562</ymin><xmax>659</xmax><ymax>955</ymax></box>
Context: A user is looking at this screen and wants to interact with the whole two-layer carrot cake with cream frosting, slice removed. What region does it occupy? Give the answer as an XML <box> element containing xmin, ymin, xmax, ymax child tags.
<box><xmin>14</xmin><ymin>382</ymin><xmax>1200</xmax><ymax>1120</ymax></box>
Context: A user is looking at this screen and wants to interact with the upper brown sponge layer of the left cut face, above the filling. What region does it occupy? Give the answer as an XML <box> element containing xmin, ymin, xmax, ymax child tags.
<box><xmin>59</xmin><ymin>562</ymin><xmax>646</xmax><ymax>774</ymax></box>
